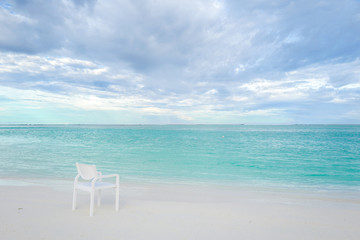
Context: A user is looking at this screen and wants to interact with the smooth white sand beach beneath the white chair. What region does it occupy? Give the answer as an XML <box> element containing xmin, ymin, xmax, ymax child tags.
<box><xmin>0</xmin><ymin>182</ymin><xmax>360</xmax><ymax>240</ymax></box>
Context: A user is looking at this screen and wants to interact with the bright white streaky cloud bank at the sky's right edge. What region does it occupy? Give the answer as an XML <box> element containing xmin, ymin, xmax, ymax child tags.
<box><xmin>234</xmin><ymin>59</ymin><xmax>360</xmax><ymax>104</ymax></box>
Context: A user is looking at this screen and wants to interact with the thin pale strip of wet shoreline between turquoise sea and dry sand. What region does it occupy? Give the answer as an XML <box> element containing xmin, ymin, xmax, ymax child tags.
<box><xmin>0</xmin><ymin>175</ymin><xmax>360</xmax><ymax>198</ymax></box>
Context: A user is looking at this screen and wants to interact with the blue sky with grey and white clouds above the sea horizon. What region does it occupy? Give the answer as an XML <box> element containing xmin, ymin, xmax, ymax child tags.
<box><xmin>0</xmin><ymin>0</ymin><xmax>360</xmax><ymax>124</ymax></box>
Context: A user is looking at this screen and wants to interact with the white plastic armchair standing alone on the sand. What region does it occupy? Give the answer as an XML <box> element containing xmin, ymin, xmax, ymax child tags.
<box><xmin>72</xmin><ymin>163</ymin><xmax>119</xmax><ymax>216</ymax></box>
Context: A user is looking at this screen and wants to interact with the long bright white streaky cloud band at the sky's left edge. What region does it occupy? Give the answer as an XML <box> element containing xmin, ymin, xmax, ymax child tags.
<box><xmin>0</xmin><ymin>52</ymin><xmax>144</xmax><ymax>89</ymax></box>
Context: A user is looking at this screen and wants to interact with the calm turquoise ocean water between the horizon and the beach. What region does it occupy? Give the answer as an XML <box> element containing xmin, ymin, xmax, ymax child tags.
<box><xmin>0</xmin><ymin>125</ymin><xmax>360</xmax><ymax>191</ymax></box>
